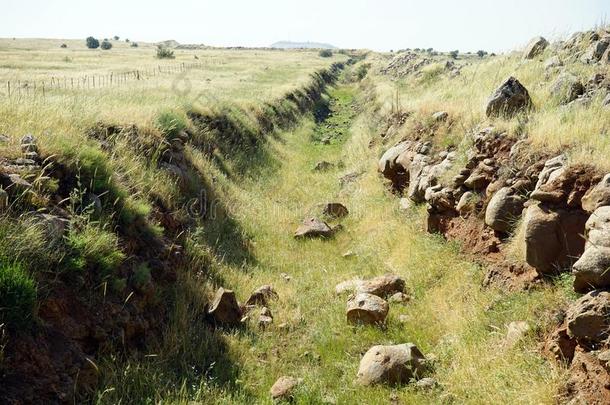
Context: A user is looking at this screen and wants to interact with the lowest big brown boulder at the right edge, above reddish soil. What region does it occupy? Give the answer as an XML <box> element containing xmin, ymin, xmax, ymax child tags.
<box><xmin>566</xmin><ymin>291</ymin><xmax>610</xmax><ymax>343</ymax></box>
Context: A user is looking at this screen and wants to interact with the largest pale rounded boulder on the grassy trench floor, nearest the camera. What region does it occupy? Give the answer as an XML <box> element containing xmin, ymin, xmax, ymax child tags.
<box><xmin>358</xmin><ymin>343</ymin><xmax>425</xmax><ymax>385</ymax></box>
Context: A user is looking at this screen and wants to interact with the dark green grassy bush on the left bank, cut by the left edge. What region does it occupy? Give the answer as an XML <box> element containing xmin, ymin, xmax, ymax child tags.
<box><xmin>0</xmin><ymin>262</ymin><xmax>37</xmax><ymax>329</ymax></box>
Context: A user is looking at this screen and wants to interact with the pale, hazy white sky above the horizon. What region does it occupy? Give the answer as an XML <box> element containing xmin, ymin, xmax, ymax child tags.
<box><xmin>0</xmin><ymin>0</ymin><xmax>610</xmax><ymax>52</ymax></box>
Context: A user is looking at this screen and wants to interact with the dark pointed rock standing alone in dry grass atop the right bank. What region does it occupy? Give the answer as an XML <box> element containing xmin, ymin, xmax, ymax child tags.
<box><xmin>486</xmin><ymin>77</ymin><xmax>532</xmax><ymax>117</ymax></box>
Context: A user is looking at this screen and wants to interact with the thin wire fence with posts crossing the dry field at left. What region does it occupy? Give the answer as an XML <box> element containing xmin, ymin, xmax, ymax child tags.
<box><xmin>0</xmin><ymin>61</ymin><xmax>210</xmax><ymax>101</ymax></box>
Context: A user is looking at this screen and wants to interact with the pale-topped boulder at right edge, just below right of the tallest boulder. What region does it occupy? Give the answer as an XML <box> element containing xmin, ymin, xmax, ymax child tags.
<box><xmin>572</xmin><ymin>246</ymin><xmax>610</xmax><ymax>293</ymax></box>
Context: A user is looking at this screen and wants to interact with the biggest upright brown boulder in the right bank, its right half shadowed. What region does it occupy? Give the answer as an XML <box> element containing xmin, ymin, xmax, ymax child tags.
<box><xmin>524</xmin><ymin>204</ymin><xmax>587</xmax><ymax>274</ymax></box>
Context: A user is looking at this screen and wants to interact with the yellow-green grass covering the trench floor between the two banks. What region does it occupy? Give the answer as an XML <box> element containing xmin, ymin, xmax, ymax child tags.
<box><xmin>98</xmin><ymin>75</ymin><xmax>564</xmax><ymax>404</ymax></box>
